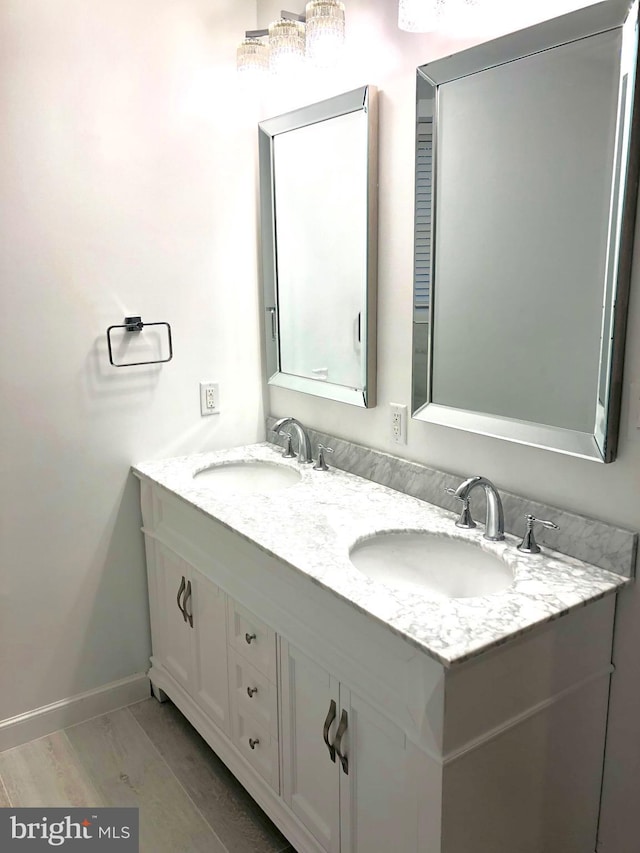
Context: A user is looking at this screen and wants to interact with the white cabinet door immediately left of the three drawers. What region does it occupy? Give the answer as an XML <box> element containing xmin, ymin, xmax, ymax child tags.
<box><xmin>187</xmin><ymin>569</ymin><xmax>230</xmax><ymax>734</ymax></box>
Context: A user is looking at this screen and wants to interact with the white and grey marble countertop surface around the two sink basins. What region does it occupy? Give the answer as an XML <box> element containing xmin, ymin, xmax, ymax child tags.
<box><xmin>133</xmin><ymin>443</ymin><xmax>629</xmax><ymax>666</ymax></box>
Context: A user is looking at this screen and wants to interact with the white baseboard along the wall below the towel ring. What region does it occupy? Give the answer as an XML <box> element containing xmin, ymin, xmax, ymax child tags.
<box><xmin>0</xmin><ymin>673</ymin><xmax>150</xmax><ymax>752</ymax></box>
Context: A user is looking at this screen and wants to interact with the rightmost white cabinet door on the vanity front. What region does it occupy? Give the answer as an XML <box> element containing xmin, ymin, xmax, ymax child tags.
<box><xmin>340</xmin><ymin>685</ymin><xmax>418</xmax><ymax>853</ymax></box>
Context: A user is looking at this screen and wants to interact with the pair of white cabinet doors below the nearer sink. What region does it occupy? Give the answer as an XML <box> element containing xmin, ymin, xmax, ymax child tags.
<box><xmin>281</xmin><ymin>641</ymin><xmax>419</xmax><ymax>853</ymax></box>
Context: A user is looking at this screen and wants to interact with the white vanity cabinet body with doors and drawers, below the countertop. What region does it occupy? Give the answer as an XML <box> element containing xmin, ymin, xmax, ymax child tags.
<box><xmin>136</xmin><ymin>477</ymin><xmax>615</xmax><ymax>853</ymax></box>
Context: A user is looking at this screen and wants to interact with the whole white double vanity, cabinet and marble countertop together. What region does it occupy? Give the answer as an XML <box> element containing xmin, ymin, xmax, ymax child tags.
<box><xmin>134</xmin><ymin>444</ymin><xmax>628</xmax><ymax>853</ymax></box>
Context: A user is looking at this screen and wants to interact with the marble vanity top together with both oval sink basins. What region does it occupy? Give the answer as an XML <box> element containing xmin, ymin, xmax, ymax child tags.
<box><xmin>133</xmin><ymin>443</ymin><xmax>629</xmax><ymax>667</ymax></box>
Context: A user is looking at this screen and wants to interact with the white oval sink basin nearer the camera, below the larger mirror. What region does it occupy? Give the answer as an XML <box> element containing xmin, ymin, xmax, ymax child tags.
<box><xmin>349</xmin><ymin>531</ymin><xmax>513</xmax><ymax>598</ymax></box>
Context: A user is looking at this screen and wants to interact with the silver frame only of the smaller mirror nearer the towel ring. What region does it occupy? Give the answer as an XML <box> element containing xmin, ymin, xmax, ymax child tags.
<box><xmin>258</xmin><ymin>86</ymin><xmax>378</xmax><ymax>408</ymax></box>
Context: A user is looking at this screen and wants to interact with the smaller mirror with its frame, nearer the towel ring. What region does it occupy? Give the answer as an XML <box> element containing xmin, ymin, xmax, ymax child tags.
<box><xmin>259</xmin><ymin>86</ymin><xmax>377</xmax><ymax>407</ymax></box>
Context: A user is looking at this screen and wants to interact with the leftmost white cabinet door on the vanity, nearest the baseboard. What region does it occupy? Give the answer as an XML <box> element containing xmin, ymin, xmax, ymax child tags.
<box><xmin>153</xmin><ymin>544</ymin><xmax>192</xmax><ymax>690</ymax></box>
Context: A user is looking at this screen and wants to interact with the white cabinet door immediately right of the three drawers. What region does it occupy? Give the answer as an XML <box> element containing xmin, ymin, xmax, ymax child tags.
<box><xmin>281</xmin><ymin>640</ymin><xmax>340</xmax><ymax>853</ymax></box>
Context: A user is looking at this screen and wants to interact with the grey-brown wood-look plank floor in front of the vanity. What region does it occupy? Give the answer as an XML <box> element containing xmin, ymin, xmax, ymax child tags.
<box><xmin>0</xmin><ymin>699</ymin><xmax>295</xmax><ymax>853</ymax></box>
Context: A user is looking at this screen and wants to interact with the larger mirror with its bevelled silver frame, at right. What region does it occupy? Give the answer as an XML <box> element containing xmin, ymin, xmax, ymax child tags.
<box><xmin>412</xmin><ymin>0</ymin><xmax>638</xmax><ymax>462</ymax></box>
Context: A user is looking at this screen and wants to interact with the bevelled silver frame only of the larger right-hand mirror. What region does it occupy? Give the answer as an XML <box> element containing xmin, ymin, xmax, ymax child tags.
<box><xmin>412</xmin><ymin>0</ymin><xmax>640</xmax><ymax>462</ymax></box>
